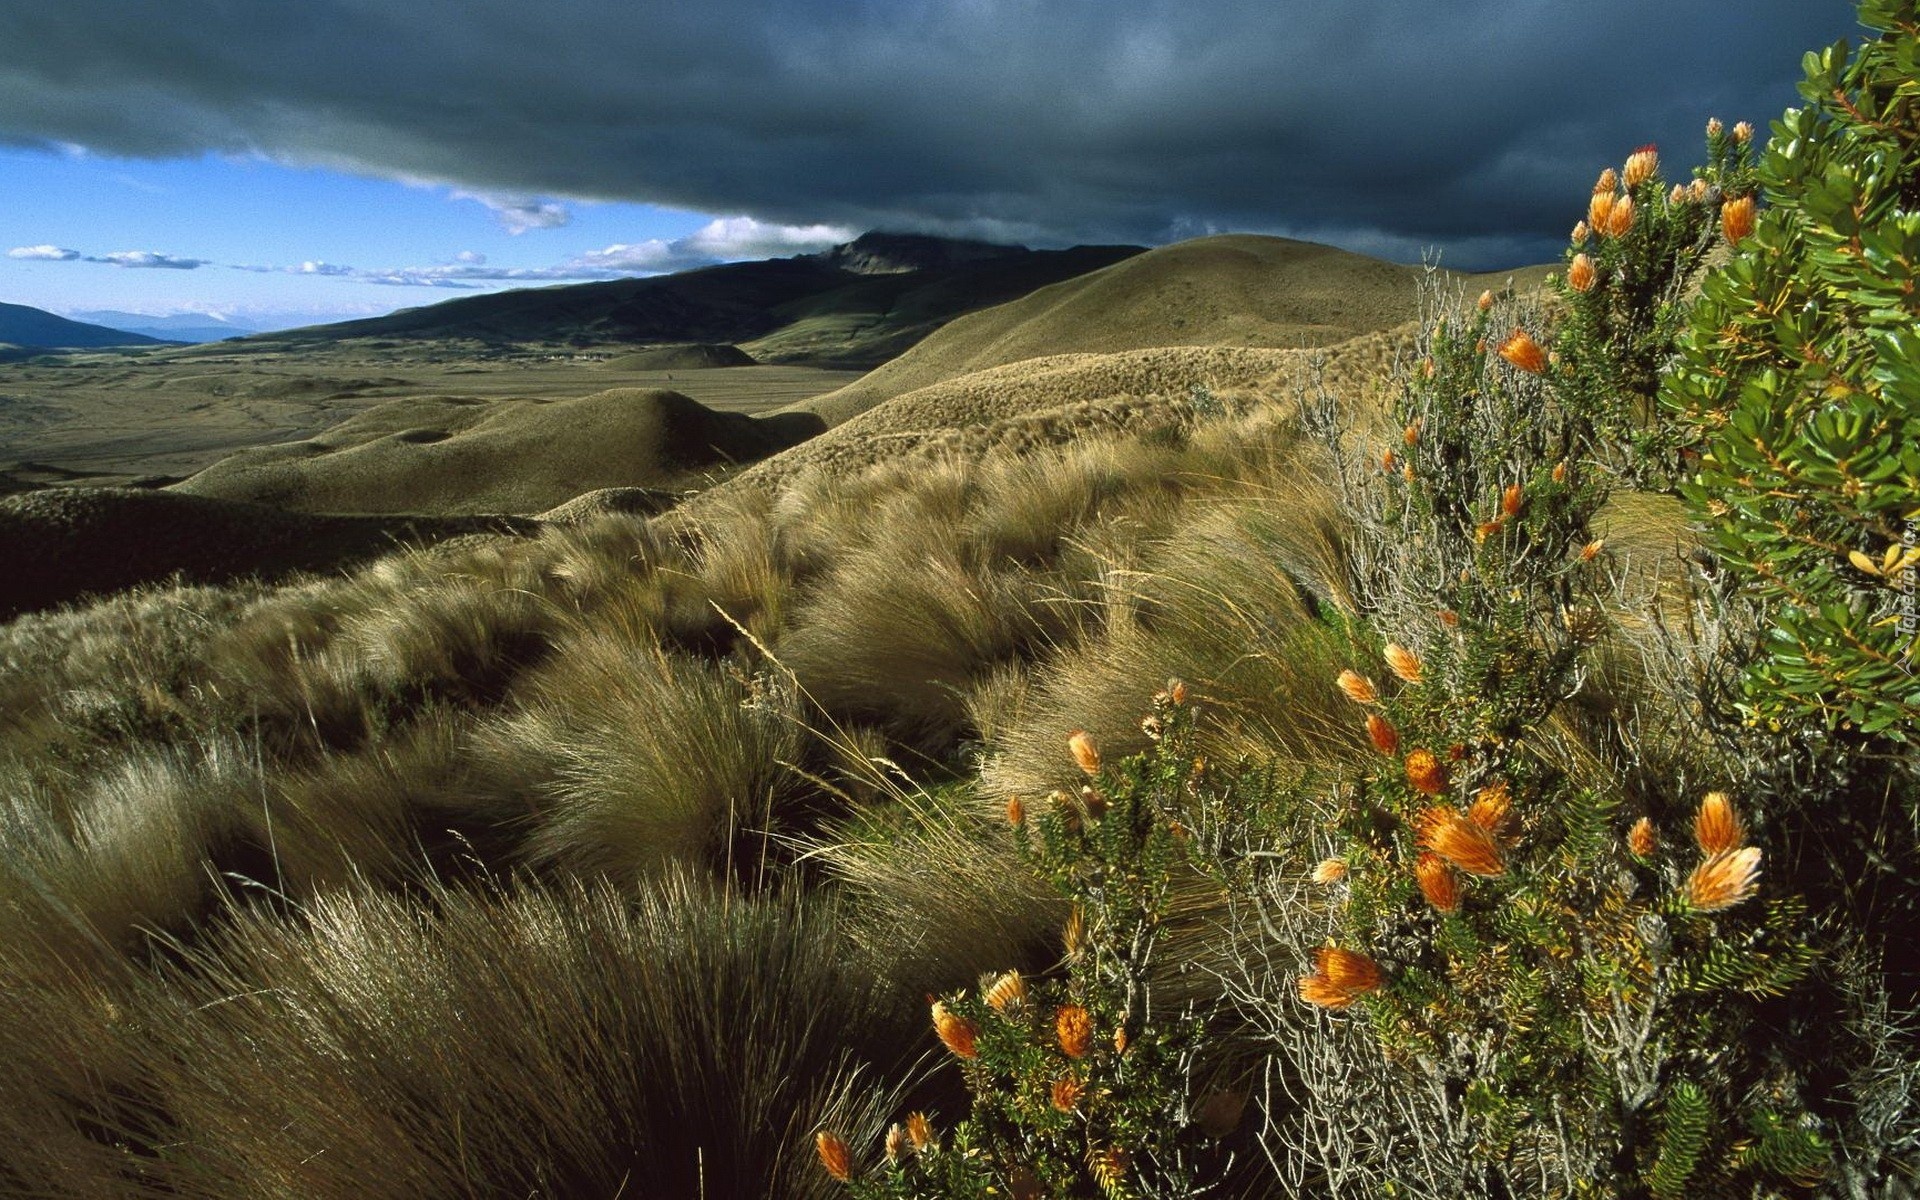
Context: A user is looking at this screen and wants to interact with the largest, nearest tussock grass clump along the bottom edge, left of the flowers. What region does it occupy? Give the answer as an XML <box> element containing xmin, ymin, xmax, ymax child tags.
<box><xmin>0</xmin><ymin>876</ymin><xmax>912</xmax><ymax>1200</ymax></box>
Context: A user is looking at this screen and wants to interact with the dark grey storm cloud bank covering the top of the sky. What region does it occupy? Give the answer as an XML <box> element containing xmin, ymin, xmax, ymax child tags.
<box><xmin>0</xmin><ymin>0</ymin><xmax>1855</xmax><ymax>265</ymax></box>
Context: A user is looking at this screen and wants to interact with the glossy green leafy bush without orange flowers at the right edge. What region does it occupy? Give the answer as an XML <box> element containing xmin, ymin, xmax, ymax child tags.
<box><xmin>1663</xmin><ymin>0</ymin><xmax>1920</xmax><ymax>745</ymax></box>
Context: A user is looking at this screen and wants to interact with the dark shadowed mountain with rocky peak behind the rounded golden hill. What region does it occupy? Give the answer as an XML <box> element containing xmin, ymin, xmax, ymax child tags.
<box><xmin>261</xmin><ymin>232</ymin><xmax>1144</xmax><ymax>367</ymax></box>
